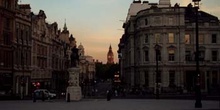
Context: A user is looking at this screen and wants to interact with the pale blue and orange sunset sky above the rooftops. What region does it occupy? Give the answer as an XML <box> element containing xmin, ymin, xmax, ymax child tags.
<box><xmin>19</xmin><ymin>0</ymin><xmax>220</xmax><ymax>63</ymax></box>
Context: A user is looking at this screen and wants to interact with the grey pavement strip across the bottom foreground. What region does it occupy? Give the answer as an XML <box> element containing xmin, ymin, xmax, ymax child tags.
<box><xmin>0</xmin><ymin>99</ymin><xmax>220</xmax><ymax>110</ymax></box>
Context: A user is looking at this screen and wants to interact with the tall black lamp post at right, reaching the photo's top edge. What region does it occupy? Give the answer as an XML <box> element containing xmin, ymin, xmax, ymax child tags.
<box><xmin>192</xmin><ymin>0</ymin><xmax>202</xmax><ymax>108</ymax></box>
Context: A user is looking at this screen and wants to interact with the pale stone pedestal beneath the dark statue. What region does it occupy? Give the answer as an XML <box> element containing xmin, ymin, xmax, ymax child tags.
<box><xmin>66</xmin><ymin>67</ymin><xmax>82</xmax><ymax>101</ymax></box>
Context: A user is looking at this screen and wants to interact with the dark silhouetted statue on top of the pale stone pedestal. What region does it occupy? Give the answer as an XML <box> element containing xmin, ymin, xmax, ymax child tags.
<box><xmin>71</xmin><ymin>46</ymin><xmax>79</xmax><ymax>67</ymax></box>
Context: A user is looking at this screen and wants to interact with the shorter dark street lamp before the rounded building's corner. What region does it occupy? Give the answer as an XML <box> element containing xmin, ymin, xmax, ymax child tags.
<box><xmin>154</xmin><ymin>44</ymin><xmax>160</xmax><ymax>99</ymax></box>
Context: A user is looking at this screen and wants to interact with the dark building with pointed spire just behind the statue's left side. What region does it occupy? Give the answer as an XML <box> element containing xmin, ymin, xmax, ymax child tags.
<box><xmin>49</xmin><ymin>23</ymin><xmax>70</xmax><ymax>93</ymax></box>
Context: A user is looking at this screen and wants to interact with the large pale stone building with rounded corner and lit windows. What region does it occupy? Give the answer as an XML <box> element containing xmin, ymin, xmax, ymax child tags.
<box><xmin>118</xmin><ymin>0</ymin><xmax>220</xmax><ymax>93</ymax></box>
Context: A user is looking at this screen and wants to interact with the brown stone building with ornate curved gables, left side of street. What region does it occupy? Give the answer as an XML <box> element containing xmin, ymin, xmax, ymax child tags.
<box><xmin>31</xmin><ymin>10</ymin><xmax>53</xmax><ymax>89</ymax></box>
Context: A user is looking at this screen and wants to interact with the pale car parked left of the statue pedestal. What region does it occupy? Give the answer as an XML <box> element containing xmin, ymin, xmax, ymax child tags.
<box><xmin>34</xmin><ymin>89</ymin><xmax>57</xmax><ymax>99</ymax></box>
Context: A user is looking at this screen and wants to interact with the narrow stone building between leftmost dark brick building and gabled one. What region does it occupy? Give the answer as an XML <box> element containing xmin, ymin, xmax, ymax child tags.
<box><xmin>13</xmin><ymin>4</ymin><xmax>32</xmax><ymax>98</ymax></box>
